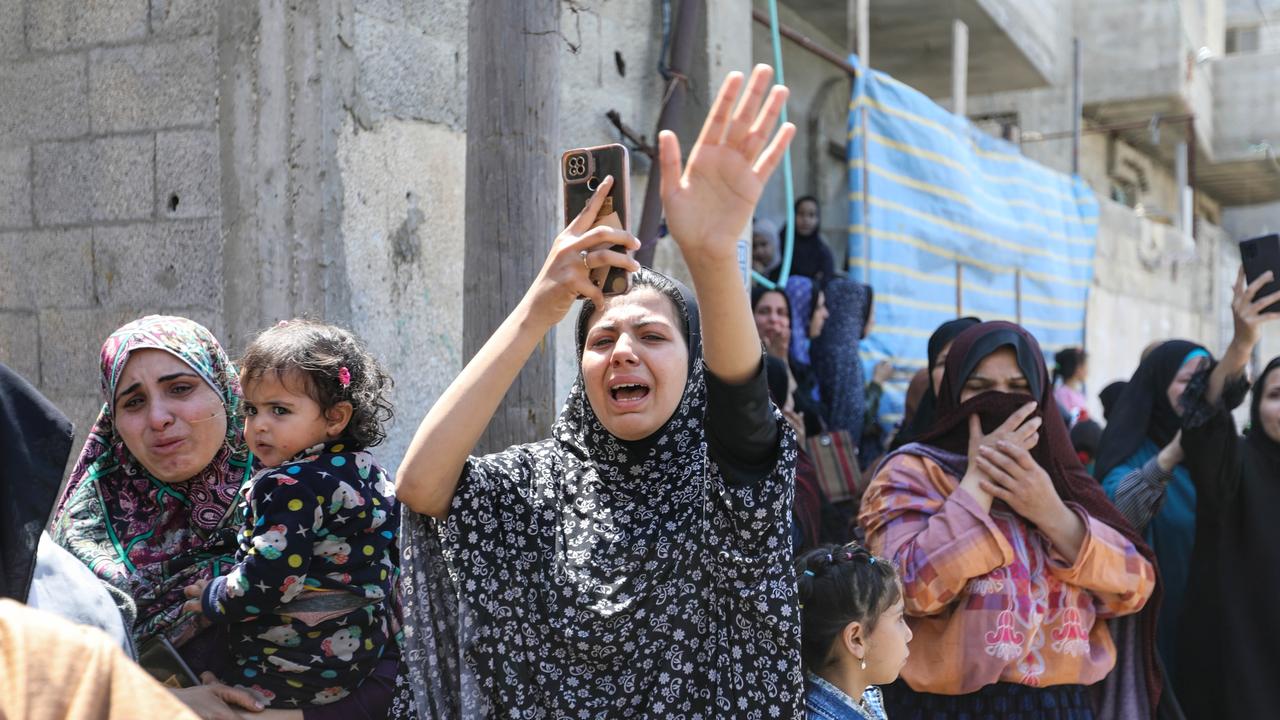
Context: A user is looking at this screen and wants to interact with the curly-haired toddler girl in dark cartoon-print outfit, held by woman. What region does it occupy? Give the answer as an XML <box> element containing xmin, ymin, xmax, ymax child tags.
<box><xmin>187</xmin><ymin>320</ymin><xmax>399</xmax><ymax>707</ymax></box>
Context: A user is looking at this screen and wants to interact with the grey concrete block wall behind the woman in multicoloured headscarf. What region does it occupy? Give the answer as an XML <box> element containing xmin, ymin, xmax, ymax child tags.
<box><xmin>0</xmin><ymin>0</ymin><xmax>223</xmax><ymax>456</ymax></box>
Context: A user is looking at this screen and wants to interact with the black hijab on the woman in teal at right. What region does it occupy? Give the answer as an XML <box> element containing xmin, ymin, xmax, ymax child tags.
<box><xmin>1093</xmin><ymin>340</ymin><xmax>1208</xmax><ymax>480</ymax></box>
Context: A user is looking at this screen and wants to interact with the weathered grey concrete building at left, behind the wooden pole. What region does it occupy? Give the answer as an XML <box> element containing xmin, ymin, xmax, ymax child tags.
<box><xmin>0</xmin><ymin>0</ymin><xmax>751</xmax><ymax>466</ymax></box>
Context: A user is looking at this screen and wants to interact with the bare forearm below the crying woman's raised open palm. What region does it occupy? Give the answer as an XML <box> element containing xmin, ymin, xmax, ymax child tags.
<box><xmin>685</xmin><ymin>245</ymin><xmax>760</xmax><ymax>384</ymax></box>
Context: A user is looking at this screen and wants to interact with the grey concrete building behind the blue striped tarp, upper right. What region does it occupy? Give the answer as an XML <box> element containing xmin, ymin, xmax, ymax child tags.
<box><xmin>753</xmin><ymin>0</ymin><xmax>1280</xmax><ymax>420</ymax></box>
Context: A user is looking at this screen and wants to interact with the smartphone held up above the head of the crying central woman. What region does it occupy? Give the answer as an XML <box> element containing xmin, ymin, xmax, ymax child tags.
<box><xmin>561</xmin><ymin>145</ymin><xmax>631</xmax><ymax>295</ymax></box>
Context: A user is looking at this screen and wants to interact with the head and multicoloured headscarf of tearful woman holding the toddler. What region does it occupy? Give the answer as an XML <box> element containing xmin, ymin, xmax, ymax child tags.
<box><xmin>52</xmin><ymin>315</ymin><xmax>252</xmax><ymax>651</ymax></box>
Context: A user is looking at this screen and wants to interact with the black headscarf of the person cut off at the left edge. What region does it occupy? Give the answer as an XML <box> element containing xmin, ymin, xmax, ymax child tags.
<box><xmin>0</xmin><ymin>363</ymin><xmax>73</xmax><ymax>603</ymax></box>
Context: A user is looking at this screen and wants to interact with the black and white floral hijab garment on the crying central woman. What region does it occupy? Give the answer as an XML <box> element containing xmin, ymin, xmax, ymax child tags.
<box><xmin>402</xmin><ymin>270</ymin><xmax>801</xmax><ymax>719</ymax></box>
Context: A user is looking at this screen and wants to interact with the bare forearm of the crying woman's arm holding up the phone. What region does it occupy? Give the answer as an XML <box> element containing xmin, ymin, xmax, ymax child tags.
<box><xmin>396</xmin><ymin>302</ymin><xmax>548</xmax><ymax>519</ymax></box>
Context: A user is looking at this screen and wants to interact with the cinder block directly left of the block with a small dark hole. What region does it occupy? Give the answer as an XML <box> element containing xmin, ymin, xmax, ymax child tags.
<box><xmin>35</xmin><ymin>135</ymin><xmax>155</xmax><ymax>225</ymax></box>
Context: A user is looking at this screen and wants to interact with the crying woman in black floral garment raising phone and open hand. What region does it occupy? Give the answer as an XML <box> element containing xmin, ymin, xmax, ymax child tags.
<box><xmin>397</xmin><ymin>65</ymin><xmax>801</xmax><ymax>719</ymax></box>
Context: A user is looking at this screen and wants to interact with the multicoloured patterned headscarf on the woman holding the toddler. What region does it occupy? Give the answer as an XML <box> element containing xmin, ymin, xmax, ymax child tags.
<box><xmin>52</xmin><ymin>315</ymin><xmax>253</xmax><ymax>644</ymax></box>
